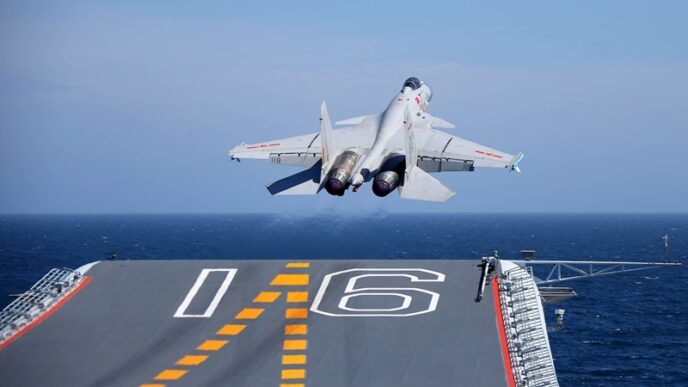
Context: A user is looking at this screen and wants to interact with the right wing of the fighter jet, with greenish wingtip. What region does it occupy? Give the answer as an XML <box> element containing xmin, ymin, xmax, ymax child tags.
<box><xmin>418</xmin><ymin>130</ymin><xmax>523</xmax><ymax>172</ymax></box>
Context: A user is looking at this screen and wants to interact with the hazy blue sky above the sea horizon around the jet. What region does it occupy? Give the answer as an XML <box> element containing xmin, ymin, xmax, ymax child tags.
<box><xmin>0</xmin><ymin>1</ymin><xmax>688</xmax><ymax>214</ymax></box>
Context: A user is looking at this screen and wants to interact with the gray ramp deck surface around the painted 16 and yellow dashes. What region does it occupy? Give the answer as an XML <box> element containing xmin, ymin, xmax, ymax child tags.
<box><xmin>0</xmin><ymin>260</ymin><xmax>506</xmax><ymax>386</ymax></box>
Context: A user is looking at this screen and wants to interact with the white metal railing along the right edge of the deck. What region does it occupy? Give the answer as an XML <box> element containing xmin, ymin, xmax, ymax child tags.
<box><xmin>499</xmin><ymin>267</ymin><xmax>559</xmax><ymax>387</ymax></box>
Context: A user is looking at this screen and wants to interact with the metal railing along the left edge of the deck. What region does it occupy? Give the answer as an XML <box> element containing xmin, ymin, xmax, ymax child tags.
<box><xmin>0</xmin><ymin>268</ymin><xmax>84</xmax><ymax>343</ymax></box>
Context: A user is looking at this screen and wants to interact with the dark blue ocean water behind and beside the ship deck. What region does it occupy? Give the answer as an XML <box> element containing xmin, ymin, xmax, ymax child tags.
<box><xmin>0</xmin><ymin>213</ymin><xmax>688</xmax><ymax>386</ymax></box>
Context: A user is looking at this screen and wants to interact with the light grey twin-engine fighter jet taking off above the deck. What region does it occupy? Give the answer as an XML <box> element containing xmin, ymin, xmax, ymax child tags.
<box><xmin>229</xmin><ymin>77</ymin><xmax>523</xmax><ymax>202</ymax></box>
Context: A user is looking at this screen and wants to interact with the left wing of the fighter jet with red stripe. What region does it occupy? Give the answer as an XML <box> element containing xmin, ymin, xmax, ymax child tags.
<box><xmin>229</xmin><ymin>133</ymin><xmax>321</xmax><ymax>167</ymax></box>
